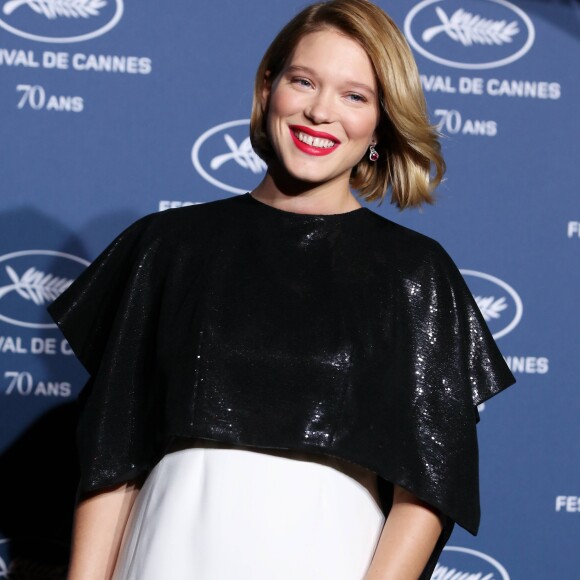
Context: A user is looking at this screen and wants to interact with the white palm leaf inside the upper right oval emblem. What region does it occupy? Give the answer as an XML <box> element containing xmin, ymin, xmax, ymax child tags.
<box><xmin>422</xmin><ymin>6</ymin><xmax>520</xmax><ymax>46</ymax></box>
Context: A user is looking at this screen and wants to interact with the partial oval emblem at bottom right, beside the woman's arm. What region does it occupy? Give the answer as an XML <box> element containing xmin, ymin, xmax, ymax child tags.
<box><xmin>431</xmin><ymin>546</ymin><xmax>510</xmax><ymax>580</ymax></box>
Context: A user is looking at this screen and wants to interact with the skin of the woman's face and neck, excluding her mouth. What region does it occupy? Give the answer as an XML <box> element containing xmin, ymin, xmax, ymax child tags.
<box><xmin>252</xmin><ymin>30</ymin><xmax>379</xmax><ymax>214</ymax></box>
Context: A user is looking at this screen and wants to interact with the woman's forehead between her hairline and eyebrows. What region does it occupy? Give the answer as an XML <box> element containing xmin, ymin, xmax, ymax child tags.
<box><xmin>286</xmin><ymin>28</ymin><xmax>376</xmax><ymax>86</ymax></box>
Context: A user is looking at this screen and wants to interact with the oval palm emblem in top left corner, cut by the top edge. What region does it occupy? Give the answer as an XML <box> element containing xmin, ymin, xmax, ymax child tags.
<box><xmin>0</xmin><ymin>0</ymin><xmax>123</xmax><ymax>43</ymax></box>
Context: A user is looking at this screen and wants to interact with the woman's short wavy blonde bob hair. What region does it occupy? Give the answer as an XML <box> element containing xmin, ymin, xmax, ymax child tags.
<box><xmin>250</xmin><ymin>0</ymin><xmax>445</xmax><ymax>209</ymax></box>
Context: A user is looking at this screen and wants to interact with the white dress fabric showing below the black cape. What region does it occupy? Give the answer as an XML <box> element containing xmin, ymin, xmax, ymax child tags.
<box><xmin>113</xmin><ymin>447</ymin><xmax>384</xmax><ymax>580</ymax></box>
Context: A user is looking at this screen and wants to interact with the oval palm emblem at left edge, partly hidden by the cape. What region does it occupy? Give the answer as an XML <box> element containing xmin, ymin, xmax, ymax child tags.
<box><xmin>0</xmin><ymin>250</ymin><xmax>89</xmax><ymax>328</ymax></box>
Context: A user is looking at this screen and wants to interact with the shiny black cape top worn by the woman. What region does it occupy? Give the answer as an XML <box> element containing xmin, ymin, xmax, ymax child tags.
<box><xmin>50</xmin><ymin>194</ymin><xmax>514</xmax><ymax>572</ymax></box>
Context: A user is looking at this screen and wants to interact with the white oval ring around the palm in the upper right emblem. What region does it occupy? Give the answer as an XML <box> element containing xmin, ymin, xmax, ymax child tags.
<box><xmin>404</xmin><ymin>0</ymin><xmax>536</xmax><ymax>70</ymax></box>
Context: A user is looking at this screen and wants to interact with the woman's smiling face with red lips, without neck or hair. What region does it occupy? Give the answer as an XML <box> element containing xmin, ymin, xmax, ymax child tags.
<box><xmin>262</xmin><ymin>29</ymin><xmax>379</xmax><ymax>188</ymax></box>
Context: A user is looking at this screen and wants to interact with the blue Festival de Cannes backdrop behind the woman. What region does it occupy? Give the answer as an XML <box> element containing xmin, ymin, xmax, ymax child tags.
<box><xmin>0</xmin><ymin>0</ymin><xmax>580</xmax><ymax>580</ymax></box>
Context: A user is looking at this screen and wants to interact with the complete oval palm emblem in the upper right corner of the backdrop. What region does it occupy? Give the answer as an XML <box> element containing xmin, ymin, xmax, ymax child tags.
<box><xmin>404</xmin><ymin>0</ymin><xmax>536</xmax><ymax>70</ymax></box>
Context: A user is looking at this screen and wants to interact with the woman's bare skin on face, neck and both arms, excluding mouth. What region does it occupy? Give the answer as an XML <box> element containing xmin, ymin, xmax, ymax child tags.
<box><xmin>68</xmin><ymin>29</ymin><xmax>442</xmax><ymax>580</ymax></box>
